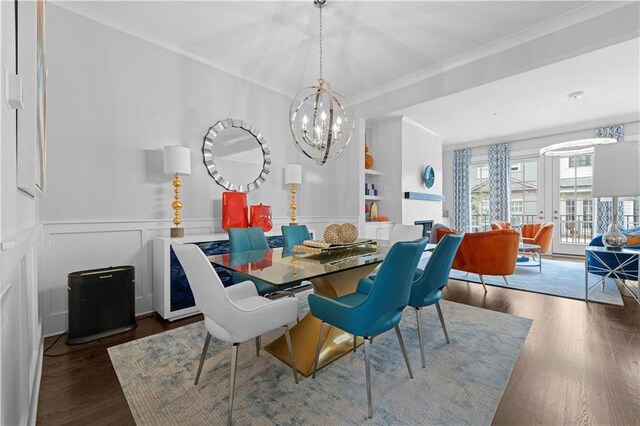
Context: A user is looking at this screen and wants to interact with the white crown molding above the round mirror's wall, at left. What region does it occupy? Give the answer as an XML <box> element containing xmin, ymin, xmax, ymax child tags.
<box><xmin>49</xmin><ymin>1</ymin><xmax>294</xmax><ymax>98</ymax></box>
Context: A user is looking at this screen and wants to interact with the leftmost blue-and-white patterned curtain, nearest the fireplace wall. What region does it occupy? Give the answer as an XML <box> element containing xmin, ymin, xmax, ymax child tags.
<box><xmin>452</xmin><ymin>149</ymin><xmax>471</xmax><ymax>232</ymax></box>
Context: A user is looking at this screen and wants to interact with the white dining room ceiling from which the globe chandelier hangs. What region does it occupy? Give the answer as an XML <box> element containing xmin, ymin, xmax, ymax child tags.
<box><xmin>55</xmin><ymin>0</ymin><xmax>627</xmax><ymax>103</ymax></box>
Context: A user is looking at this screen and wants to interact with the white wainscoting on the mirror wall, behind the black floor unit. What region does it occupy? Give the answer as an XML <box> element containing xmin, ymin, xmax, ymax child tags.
<box><xmin>39</xmin><ymin>216</ymin><xmax>358</xmax><ymax>336</ymax></box>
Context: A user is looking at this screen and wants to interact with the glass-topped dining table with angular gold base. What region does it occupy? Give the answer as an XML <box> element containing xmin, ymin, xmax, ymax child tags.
<box><xmin>208</xmin><ymin>241</ymin><xmax>435</xmax><ymax>377</ymax></box>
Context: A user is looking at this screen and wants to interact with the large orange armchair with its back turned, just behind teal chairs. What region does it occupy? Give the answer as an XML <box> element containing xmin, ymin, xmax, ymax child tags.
<box><xmin>438</xmin><ymin>229</ymin><xmax>520</xmax><ymax>293</ymax></box>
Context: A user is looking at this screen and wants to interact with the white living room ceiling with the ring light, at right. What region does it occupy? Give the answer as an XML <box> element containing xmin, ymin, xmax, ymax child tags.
<box><xmin>401</xmin><ymin>38</ymin><xmax>640</xmax><ymax>145</ymax></box>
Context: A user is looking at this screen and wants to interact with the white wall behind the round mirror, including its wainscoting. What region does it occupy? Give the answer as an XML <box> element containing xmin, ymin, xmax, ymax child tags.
<box><xmin>40</xmin><ymin>5</ymin><xmax>357</xmax><ymax>335</ymax></box>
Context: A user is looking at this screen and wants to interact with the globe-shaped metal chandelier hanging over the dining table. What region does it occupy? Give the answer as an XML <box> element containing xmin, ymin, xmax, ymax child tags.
<box><xmin>289</xmin><ymin>0</ymin><xmax>354</xmax><ymax>165</ymax></box>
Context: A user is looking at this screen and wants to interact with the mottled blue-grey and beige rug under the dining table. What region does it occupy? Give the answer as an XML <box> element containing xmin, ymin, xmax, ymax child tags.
<box><xmin>109</xmin><ymin>294</ymin><xmax>532</xmax><ymax>425</ymax></box>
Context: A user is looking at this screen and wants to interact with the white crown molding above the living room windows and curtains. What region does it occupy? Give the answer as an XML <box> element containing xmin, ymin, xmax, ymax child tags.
<box><xmin>442</xmin><ymin>113</ymin><xmax>640</xmax><ymax>152</ymax></box>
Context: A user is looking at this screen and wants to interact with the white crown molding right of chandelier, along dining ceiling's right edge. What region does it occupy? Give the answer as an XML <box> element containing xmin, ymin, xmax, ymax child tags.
<box><xmin>351</xmin><ymin>1</ymin><xmax>634</xmax><ymax>105</ymax></box>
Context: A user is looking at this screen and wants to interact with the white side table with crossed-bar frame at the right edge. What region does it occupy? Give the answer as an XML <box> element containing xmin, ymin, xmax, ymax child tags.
<box><xmin>584</xmin><ymin>246</ymin><xmax>640</xmax><ymax>303</ymax></box>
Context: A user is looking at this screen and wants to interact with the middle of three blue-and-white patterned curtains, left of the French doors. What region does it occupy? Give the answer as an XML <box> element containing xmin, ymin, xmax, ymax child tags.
<box><xmin>489</xmin><ymin>143</ymin><xmax>511</xmax><ymax>222</ymax></box>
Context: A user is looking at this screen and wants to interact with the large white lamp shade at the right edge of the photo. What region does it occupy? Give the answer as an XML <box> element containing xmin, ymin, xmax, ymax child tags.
<box><xmin>591</xmin><ymin>141</ymin><xmax>640</xmax><ymax>197</ymax></box>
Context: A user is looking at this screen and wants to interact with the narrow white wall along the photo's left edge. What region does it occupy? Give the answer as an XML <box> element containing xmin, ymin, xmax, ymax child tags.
<box><xmin>0</xmin><ymin>2</ymin><xmax>42</xmax><ymax>425</ymax></box>
